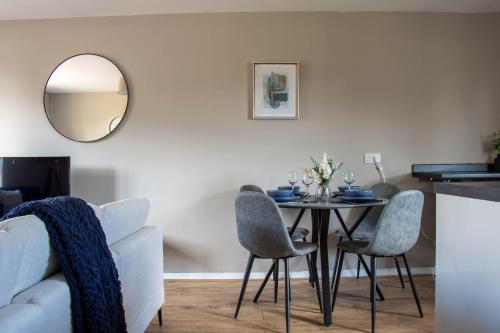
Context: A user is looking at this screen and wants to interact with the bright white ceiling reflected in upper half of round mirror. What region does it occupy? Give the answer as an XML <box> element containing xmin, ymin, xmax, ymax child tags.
<box><xmin>47</xmin><ymin>54</ymin><xmax>123</xmax><ymax>94</ymax></box>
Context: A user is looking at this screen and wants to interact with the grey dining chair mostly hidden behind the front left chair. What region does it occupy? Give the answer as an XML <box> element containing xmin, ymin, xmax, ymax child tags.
<box><xmin>240</xmin><ymin>184</ymin><xmax>314</xmax><ymax>294</ymax></box>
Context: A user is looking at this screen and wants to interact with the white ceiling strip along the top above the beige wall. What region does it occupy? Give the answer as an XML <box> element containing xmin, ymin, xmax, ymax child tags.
<box><xmin>0</xmin><ymin>0</ymin><xmax>500</xmax><ymax>20</ymax></box>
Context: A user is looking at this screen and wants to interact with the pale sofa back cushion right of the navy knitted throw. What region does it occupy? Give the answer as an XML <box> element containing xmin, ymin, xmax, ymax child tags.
<box><xmin>91</xmin><ymin>199</ymin><xmax>149</xmax><ymax>245</ymax></box>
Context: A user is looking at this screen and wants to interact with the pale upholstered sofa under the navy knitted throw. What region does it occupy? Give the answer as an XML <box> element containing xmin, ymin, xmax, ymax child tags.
<box><xmin>0</xmin><ymin>199</ymin><xmax>164</xmax><ymax>333</ymax></box>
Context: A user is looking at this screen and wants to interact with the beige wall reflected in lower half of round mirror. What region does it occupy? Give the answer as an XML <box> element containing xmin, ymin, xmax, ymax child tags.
<box><xmin>45</xmin><ymin>92</ymin><xmax>127</xmax><ymax>141</ymax></box>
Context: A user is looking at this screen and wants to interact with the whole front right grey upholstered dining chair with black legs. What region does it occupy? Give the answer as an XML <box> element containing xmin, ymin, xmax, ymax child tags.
<box><xmin>332</xmin><ymin>191</ymin><xmax>424</xmax><ymax>333</ymax></box>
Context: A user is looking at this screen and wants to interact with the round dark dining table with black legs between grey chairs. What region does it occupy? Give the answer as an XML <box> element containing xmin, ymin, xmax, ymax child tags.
<box><xmin>278</xmin><ymin>199</ymin><xmax>389</xmax><ymax>326</ymax></box>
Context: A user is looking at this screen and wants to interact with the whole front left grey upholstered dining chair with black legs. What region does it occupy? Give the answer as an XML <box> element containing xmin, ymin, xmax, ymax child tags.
<box><xmin>234</xmin><ymin>191</ymin><xmax>319</xmax><ymax>332</ymax></box>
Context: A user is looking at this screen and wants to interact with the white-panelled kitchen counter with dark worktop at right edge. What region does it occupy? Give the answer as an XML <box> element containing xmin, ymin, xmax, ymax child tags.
<box><xmin>433</xmin><ymin>182</ymin><xmax>500</xmax><ymax>333</ymax></box>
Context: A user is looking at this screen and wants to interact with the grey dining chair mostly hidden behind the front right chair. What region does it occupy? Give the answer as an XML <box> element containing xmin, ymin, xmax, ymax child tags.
<box><xmin>331</xmin><ymin>183</ymin><xmax>405</xmax><ymax>289</ymax></box>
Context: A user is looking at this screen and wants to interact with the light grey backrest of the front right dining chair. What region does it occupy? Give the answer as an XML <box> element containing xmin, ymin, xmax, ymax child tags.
<box><xmin>367</xmin><ymin>191</ymin><xmax>424</xmax><ymax>256</ymax></box>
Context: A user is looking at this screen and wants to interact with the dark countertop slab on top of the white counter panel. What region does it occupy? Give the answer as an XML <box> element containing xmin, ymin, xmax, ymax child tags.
<box><xmin>434</xmin><ymin>182</ymin><xmax>500</xmax><ymax>202</ymax></box>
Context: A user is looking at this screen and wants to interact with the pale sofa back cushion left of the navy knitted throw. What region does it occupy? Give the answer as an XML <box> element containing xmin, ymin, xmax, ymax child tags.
<box><xmin>0</xmin><ymin>215</ymin><xmax>59</xmax><ymax>296</ymax></box>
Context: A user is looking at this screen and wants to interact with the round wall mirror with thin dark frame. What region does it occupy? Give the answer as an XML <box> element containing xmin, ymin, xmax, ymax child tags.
<box><xmin>44</xmin><ymin>54</ymin><xmax>128</xmax><ymax>142</ymax></box>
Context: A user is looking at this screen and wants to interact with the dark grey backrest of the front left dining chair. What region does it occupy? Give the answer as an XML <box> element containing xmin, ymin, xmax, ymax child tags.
<box><xmin>235</xmin><ymin>191</ymin><xmax>294</xmax><ymax>258</ymax></box>
